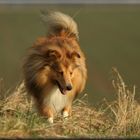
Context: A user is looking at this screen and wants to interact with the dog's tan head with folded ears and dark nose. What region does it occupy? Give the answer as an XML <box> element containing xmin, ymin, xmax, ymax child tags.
<box><xmin>46</xmin><ymin>48</ymin><xmax>80</xmax><ymax>94</ymax></box>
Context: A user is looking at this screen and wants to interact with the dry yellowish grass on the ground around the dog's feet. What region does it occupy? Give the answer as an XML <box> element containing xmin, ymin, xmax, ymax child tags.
<box><xmin>0</xmin><ymin>68</ymin><xmax>140</xmax><ymax>138</ymax></box>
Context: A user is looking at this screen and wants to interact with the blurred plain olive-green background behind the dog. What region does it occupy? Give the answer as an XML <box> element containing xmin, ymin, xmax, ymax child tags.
<box><xmin>0</xmin><ymin>5</ymin><xmax>140</xmax><ymax>104</ymax></box>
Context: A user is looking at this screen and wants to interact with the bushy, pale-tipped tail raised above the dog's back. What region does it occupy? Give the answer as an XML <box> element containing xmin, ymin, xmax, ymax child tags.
<box><xmin>41</xmin><ymin>12</ymin><xmax>79</xmax><ymax>40</ymax></box>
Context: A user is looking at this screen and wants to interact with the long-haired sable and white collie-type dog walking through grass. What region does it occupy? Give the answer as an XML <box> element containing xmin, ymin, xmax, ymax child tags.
<box><xmin>23</xmin><ymin>12</ymin><xmax>87</xmax><ymax>123</ymax></box>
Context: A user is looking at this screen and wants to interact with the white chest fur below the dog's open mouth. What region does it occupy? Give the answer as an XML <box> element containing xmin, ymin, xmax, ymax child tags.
<box><xmin>44</xmin><ymin>86</ymin><xmax>68</xmax><ymax>113</ymax></box>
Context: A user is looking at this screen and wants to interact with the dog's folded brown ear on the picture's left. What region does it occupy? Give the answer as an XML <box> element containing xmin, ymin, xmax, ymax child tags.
<box><xmin>46</xmin><ymin>49</ymin><xmax>61</xmax><ymax>58</ymax></box>
